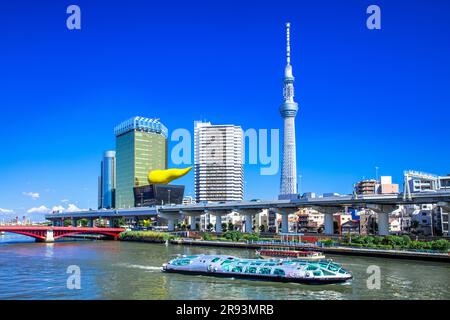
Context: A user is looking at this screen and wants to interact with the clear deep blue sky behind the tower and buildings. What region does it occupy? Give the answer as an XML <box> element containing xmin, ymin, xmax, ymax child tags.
<box><xmin>0</xmin><ymin>0</ymin><xmax>450</xmax><ymax>219</ymax></box>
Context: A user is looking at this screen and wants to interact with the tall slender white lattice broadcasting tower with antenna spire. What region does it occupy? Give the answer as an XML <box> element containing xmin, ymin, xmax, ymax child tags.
<box><xmin>279</xmin><ymin>23</ymin><xmax>298</xmax><ymax>199</ymax></box>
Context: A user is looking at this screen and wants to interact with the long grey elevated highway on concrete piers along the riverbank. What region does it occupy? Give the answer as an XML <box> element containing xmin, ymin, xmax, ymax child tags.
<box><xmin>46</xmin><ymin>191</ymin><xmax>450</xmax><ymax>235</ymax></box>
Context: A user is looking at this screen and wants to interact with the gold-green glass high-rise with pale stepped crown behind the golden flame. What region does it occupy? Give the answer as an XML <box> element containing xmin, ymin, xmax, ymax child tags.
<box><xmin>114</xmin><ymin>117</ymin><xmax>168</xmax><ymax>208</ymax></box>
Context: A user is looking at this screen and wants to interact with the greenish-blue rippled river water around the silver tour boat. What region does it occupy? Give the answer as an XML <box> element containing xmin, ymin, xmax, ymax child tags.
<box><xmin>0</xmin><ymin>235</ymin><xmax>450</xmax><ymax>300</ymax></box>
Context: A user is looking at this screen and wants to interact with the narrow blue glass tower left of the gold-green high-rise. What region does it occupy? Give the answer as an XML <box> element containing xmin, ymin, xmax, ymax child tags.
<box><xmin>98</xmin><ymin>151</ymin><xmax>116</xmax><ymax>209</ymax></box>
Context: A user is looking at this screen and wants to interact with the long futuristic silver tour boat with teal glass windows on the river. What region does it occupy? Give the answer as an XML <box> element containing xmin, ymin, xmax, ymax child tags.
<box><xmin>162</xmin><ymin>254</ymin><xmax>352</xmax><ymax>284</ymax></box>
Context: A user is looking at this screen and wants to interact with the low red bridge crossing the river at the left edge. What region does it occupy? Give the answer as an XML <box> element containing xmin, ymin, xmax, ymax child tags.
<box><xmin>0</xmin><ymin>226</ymin><xmax>125</xmax><ymax>242</ymax></box>
